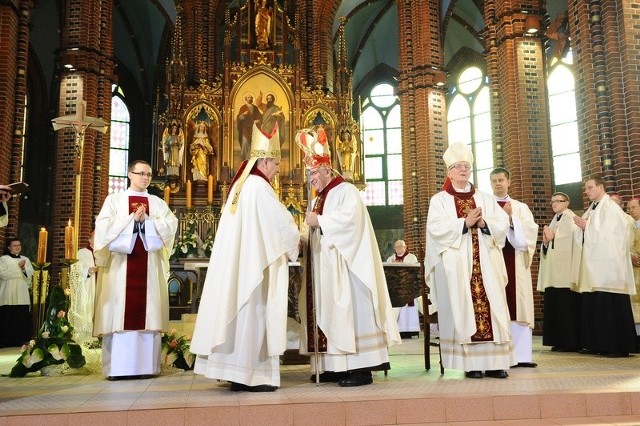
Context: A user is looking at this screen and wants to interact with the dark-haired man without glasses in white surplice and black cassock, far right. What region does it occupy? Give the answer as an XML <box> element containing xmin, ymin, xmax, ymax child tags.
<box><xmin>572</xmin><ymin>176</ymin><xmax>637</xmax><ymax>358</ymax></box>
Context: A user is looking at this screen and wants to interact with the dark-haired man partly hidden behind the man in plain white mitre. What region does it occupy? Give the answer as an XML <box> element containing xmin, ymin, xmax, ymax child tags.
<box><xmin>490</xmin><ymin>167</ymin><xmax>538</xmax><ymax>367</ymax></box>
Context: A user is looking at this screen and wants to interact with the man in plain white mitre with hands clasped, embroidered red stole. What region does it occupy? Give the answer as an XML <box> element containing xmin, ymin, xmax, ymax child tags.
<box><xmin>425</xmin><ymin>142</ymin><xmax>516</xmax><ymax>379</ymax></box>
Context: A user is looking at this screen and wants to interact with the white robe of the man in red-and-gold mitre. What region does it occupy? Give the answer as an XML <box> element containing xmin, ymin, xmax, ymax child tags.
<box><xmin>298</xmin><ymin>182</ymin><xmax>401</xmax><ymax>372</ymax></box>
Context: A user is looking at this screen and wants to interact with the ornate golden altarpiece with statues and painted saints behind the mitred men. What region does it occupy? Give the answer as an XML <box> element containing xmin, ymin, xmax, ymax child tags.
<box><xmin>152</xmin><ymin>0</ymin><xmax>364</xmax><ymax>246</ymax></box>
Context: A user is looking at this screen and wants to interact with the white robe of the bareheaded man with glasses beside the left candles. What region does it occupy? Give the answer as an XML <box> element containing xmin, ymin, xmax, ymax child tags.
<box><xmin>94</xmin><ymin>189</ymin><xmax>178</xmax><ymax>376</ymax></box>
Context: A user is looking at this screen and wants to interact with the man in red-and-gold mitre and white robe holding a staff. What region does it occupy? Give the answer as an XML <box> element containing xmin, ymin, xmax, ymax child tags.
<box><xmin>296</xmin><ymin>128</ymin><xmax>400</xmax><ymax>386</ymax></box>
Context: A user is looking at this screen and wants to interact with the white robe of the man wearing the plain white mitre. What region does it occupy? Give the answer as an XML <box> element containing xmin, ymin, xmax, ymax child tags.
<box><xmin>425</xmin><ymin>190</ymin><xmax>515</xmax><ymax>371</ymax></box>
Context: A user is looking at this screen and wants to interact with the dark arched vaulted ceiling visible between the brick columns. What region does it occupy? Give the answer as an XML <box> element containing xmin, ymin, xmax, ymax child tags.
<box><xmin>26</xmin><ymin>0</ymin><xmax>496</xmax><ymax>103</ymax></box>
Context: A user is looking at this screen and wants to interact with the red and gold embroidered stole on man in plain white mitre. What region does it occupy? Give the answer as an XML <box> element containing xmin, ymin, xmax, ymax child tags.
<box><xmin>443</xmin><ymin>179</ymin><xmax>493</xmax><ymax>342</ymax></box>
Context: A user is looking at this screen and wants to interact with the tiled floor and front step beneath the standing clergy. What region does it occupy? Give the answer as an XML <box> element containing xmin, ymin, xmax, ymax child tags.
<box><xmin>0</xmin><ymin>338</ymin><xmax>640</xmax><ymax>426</ymax></box>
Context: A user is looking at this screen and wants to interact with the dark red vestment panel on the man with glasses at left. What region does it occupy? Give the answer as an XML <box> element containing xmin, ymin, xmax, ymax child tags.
<box><xmin>124</xmin><ymin>195</ymin><xmax>150</xmax><ymax>330</ymax></box>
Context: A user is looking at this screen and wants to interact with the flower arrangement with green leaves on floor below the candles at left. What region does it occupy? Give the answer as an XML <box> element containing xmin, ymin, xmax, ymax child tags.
<box><xmin>9</xmin><ymin>286</ymin><xmax>86</xmax><ymax>377</ymax></box>
